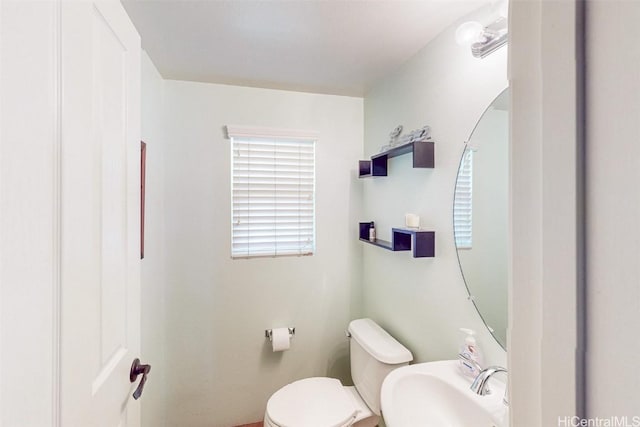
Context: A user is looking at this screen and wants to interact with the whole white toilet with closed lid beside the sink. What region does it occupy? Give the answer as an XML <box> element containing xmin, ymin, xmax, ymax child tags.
<box><xmin>264</xmin><ymin>319</ymin><xmax>413</xmax><ymax>427</ymax></box>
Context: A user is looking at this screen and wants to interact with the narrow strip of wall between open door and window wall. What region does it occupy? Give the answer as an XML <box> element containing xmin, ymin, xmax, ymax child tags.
<box><xmin>140</xmin><ymin>52</ymin><xmax>168</xmax><ymax>427</ymax></box>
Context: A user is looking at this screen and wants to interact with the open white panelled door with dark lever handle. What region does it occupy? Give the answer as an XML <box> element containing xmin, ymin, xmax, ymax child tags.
<box><xmin>60</xmin><ymin>0</ymin><xmax>142</xmax><ymax>427</ymax></box>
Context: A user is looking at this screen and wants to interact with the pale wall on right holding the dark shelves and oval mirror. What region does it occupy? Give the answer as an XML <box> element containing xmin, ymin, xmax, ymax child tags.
<box><xmin>360</xmin><ymin>5</ymin><xmax>507</xmax><ymax>366</ymax></box>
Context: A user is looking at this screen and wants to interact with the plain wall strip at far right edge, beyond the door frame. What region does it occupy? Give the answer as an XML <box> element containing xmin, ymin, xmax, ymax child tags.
<box><xmin>585</xmin><ymin>2</ymin><xmax>640</xmax><ymax>424</ymax></box>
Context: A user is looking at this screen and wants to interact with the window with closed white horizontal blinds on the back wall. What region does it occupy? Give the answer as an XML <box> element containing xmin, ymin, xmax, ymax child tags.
<box><xmin>227</xmin><ymin>127</ymin><xmax>315</xmax><ymax>258</ymax></box>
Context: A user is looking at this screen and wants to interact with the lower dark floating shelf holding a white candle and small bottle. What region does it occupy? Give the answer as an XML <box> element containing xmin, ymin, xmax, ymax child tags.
<box><xmin>360</xmin><ymin>222</ymin><xmax>436</xmax><ymax>258</ymax></box>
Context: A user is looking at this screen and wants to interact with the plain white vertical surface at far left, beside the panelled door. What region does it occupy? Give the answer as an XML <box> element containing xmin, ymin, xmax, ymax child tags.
<box><xmin>0</xmin><ymin>1</ymin><xmax>60</xmax><ymax>427</ymax></box>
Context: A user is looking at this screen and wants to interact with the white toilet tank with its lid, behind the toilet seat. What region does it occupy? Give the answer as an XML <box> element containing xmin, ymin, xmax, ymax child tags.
<box><xmin>349</xmin><ymin>319</ymin><xmax>413</xmax><ymax>415</ymax></box>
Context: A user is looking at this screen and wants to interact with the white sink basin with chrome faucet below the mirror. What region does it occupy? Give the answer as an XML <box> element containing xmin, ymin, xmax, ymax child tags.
<box><xmin>380</xmin><ymin>360</ymin><xmax>509</xmax><ymax>427</ymax></box>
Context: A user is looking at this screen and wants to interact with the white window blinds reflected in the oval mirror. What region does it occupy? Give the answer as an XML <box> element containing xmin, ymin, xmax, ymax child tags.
<box><xmin>453</xmin><ymin>148</ymin><xmax>473</xmax><ymax>249</ymax></box>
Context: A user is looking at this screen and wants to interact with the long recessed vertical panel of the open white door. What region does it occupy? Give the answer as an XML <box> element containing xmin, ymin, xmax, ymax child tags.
<box><xmin>93</xmin><ymin>3</ymin><xmax>127</xmax><ymax>380</ymax></box>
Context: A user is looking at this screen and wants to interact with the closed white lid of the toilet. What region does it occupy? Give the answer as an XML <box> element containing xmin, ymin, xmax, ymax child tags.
<box><xmin>267</xmin><ymin>378</ymin><xmax>357</xmax><ymax>427</ymax></box>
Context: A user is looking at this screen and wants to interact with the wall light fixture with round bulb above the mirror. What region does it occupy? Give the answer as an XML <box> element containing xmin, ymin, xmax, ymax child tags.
<box><xmin>456</xmin><ymin>17</ymin><xmax>509</xmax><ymax>58</ymax></box>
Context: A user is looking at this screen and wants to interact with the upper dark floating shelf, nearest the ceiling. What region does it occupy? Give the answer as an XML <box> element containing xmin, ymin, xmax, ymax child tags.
<box><xmin>359</xmin><ymin>141</ymin><xmax>435</xmax><ymax>178</ymax></box>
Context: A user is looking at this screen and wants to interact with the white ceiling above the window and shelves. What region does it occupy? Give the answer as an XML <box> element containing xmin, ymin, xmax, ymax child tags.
<box><xmin>121</xmin><ymin>0</ymin><xmax>489</xmax><ymax>96</ymax></box>
